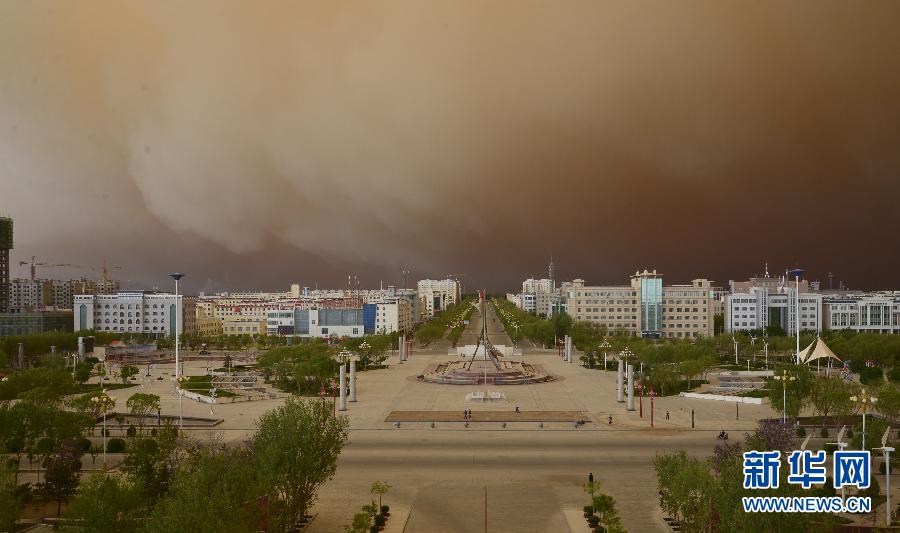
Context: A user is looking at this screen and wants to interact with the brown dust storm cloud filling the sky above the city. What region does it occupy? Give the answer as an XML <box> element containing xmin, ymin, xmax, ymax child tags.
<box><xmin>0</xmin><ymin>0</ymin><xmax>900</xmax><ymax>290</ymax></box>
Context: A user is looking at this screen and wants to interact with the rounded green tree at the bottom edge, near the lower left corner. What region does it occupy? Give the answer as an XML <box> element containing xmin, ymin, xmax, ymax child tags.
<box><xmin>63</xmin><ymin>473</ymin><xmax>144</xmax><ymax>533</ymax></box>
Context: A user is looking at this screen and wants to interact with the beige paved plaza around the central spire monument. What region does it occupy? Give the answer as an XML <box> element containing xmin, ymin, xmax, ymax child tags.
<box><xmin>100</xmin><ymin>304</ymin><xmax>773</xmax><ymax>533</ymax></box>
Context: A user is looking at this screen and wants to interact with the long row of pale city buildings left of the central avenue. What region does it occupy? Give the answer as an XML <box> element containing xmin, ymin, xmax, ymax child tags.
<box><xmin>73</xmin><ymin>280</ymin><xmax>460</xmax><ymax>337</ymax></box>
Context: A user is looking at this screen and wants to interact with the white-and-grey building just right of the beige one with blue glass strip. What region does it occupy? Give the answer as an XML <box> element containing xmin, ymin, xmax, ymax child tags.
<box><xmin>725</xmin><ymin>277</ymin><xmax>822</xmax><ymax>335</ymax></box>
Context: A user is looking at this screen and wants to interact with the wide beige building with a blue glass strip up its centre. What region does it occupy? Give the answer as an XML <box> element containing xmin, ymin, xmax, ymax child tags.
<box><xmin>565</xmin><ymin>270</ymin><xmax>714</xmax><ymax>338</ymax></box>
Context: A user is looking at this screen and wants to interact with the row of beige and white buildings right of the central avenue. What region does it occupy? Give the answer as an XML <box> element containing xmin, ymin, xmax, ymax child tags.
<box><xmin>507</xmin><ymin>267</ymin><xmax>900</xmax><ymax>338</ymax></box>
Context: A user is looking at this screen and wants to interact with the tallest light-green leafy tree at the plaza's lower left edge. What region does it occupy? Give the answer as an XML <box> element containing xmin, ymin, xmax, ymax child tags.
<box><xmin>251</xmin><ymin>398</ymin><xmax>349</xmax><ymax>524</ymax></box>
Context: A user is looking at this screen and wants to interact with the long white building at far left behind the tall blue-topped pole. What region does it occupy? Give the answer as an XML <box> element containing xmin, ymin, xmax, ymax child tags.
<box><xmin>74</xmin><ymin>291</ymin><xmax>197</xmax><ymax>335</ymax></box>
